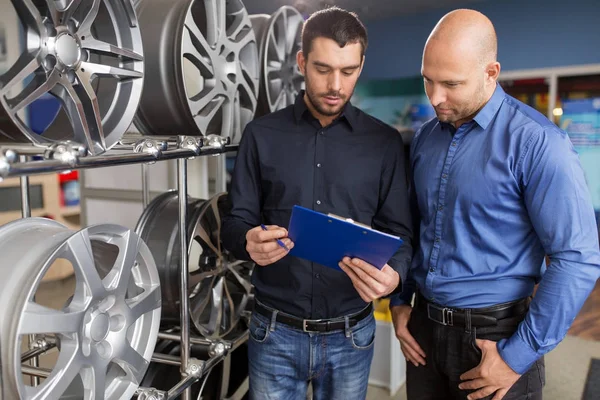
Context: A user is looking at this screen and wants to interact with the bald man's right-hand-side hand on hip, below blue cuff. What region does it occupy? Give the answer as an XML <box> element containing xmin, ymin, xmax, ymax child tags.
<box><xmin>458</xmin><ymin>339</ymin><xmax>521</xmax><ymax>400</ymax></box>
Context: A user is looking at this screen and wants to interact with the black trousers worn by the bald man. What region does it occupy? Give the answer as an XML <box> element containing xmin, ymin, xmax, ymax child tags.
<box><xmin>406</xmin><ymin>301</ymin><xmax>545</xmax><ymax>400</ymax></box>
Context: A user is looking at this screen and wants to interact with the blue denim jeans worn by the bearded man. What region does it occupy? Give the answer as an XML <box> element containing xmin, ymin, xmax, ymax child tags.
<box><xmin>248</xmin><ymin>304</ymin><xmax>375</xmax><ymax>400</ymax></box>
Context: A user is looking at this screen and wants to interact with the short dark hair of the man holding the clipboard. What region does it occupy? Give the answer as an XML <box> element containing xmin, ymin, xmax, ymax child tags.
<box><xmin>302</xmin><ymin>7</ymin><xmax>368</xmax><ymax>57</ymax></box>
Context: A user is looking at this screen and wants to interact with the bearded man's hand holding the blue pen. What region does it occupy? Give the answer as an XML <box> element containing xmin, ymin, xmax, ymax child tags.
<box><xmin>246</xmin><ymin>225</ymin><xmax>294</xmax><ymax>267</ymax></box>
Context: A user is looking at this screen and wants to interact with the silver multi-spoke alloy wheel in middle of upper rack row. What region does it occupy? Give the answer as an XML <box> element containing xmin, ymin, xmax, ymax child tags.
<box><xmin>135</xmin><ymin>0</ymin><xmax>260</xmax><ymax>143</ymax></box>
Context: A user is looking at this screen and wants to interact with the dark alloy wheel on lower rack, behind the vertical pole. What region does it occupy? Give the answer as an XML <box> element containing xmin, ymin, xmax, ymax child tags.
<box><xmin>136</xmin><ymin>191</ymin><xmax>252</xmax><ymax>338</ymax></box>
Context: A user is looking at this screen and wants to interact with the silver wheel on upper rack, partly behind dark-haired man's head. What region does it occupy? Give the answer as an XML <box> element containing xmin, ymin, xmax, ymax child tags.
<box><xmin>251</xmin><ymin>6</ymin><xmax>304</xmax><ymax>115</ymax></box>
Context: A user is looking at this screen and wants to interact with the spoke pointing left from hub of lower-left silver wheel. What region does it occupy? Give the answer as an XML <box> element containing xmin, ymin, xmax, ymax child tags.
<box><xmin>19</xmin><ymin>301</ymin><xmax>85</xmax><ymax>335</ymax></box>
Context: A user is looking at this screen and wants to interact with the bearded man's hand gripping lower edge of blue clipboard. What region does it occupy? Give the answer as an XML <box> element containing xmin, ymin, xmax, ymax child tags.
<box><xmin>339</xmin><ymin>257</ymin><xmax>400</xmax><ymax>303</ymax></box>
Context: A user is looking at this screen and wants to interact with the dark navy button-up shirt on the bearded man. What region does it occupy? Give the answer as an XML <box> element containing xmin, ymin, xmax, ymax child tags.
<box><xmin>221</xmin><ymin>92</ymin><xmax>412</xmax><ymax>319</ymax></box>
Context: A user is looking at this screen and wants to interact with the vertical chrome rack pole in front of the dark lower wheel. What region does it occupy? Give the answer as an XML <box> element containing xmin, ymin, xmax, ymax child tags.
<box><xmin>177</xmin><ymin>158</ymin><xmax>192</xmax><ymax>400</ymax></box>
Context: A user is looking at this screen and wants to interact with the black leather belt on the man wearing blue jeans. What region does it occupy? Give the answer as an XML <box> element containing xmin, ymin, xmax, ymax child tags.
<box><xmin>254</xmin><ymin>302</ymin><xmax>373</xmax><ymax>332</ymax></box>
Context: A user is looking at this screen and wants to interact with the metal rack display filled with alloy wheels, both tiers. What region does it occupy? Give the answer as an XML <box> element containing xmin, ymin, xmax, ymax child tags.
<box><xmin>0</xmin><ymin>0</ymin><xmax>304</xmax><ymax>400</ymax></box>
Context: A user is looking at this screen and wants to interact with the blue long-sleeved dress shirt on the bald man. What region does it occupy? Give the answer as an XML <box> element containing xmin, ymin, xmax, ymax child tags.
<box><xmin>391</xmin><ymin>85</ymin><xmax>600</xmax><ymax>374</ymax></box>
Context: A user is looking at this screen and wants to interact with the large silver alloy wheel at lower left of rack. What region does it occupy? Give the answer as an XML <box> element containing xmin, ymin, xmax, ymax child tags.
<box><xmin>0</xmin><ymin>218</ymin><xmax>160</xmax><ymax>400</ymax></box>
